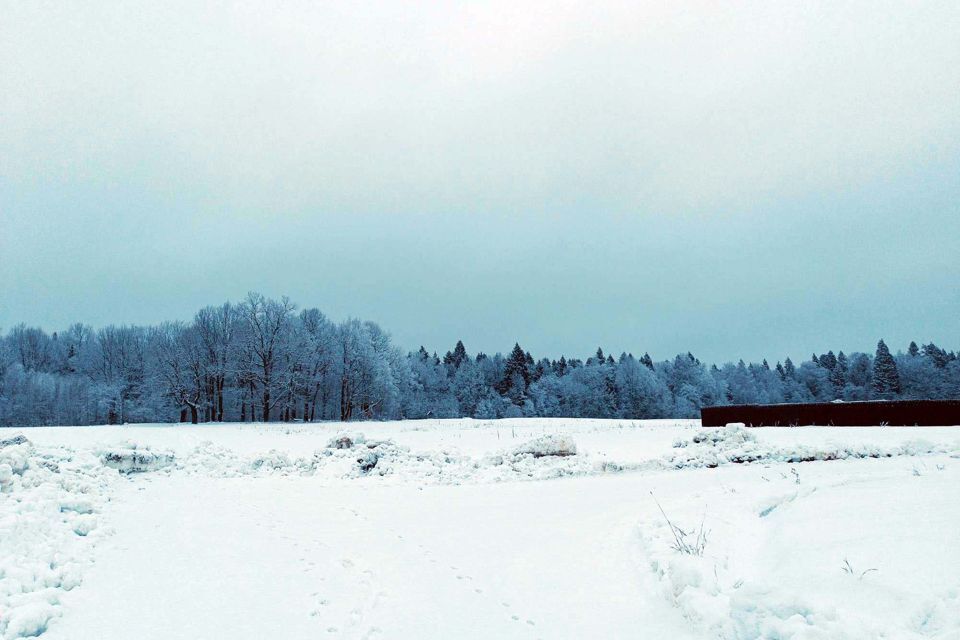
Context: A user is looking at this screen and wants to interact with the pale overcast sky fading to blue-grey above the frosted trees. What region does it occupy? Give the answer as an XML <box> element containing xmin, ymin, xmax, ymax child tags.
<box><xmin>0</xmin><ymin>0</ymin><xmax>960</xmax><ymax>362</ymax></box>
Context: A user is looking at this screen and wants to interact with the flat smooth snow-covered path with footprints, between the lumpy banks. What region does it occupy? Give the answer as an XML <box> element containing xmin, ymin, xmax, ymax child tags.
<box><xmin>44</xmin><ymin>476</ymin><xmax>695</xmax><ymax>640</ymax></box>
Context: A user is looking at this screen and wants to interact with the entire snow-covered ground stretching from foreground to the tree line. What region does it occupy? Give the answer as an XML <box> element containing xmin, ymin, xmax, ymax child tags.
<box><xmin>0</xmin><ymin>419</ymin><xmax>960</xmax><ymax>640</ymax></box>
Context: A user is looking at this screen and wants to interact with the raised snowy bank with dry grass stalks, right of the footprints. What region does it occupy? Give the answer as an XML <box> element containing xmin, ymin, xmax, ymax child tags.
<box><xmin>638</xmin><ymin>456</ymin><xmax>960</xmax><ymax>640</ymax></box>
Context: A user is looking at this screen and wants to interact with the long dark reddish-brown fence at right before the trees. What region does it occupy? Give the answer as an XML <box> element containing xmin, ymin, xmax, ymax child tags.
<box><xmin>700</xmin><ymin>400</ymin><xmax>960</xmax><ymax>427</ymax></box>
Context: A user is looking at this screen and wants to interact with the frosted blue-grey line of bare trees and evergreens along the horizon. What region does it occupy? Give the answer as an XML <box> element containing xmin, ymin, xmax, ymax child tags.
<box><xmin>0</xmin><ymin>293</ymin><xmax>960</xmax><ymax>426</ymax></box>
